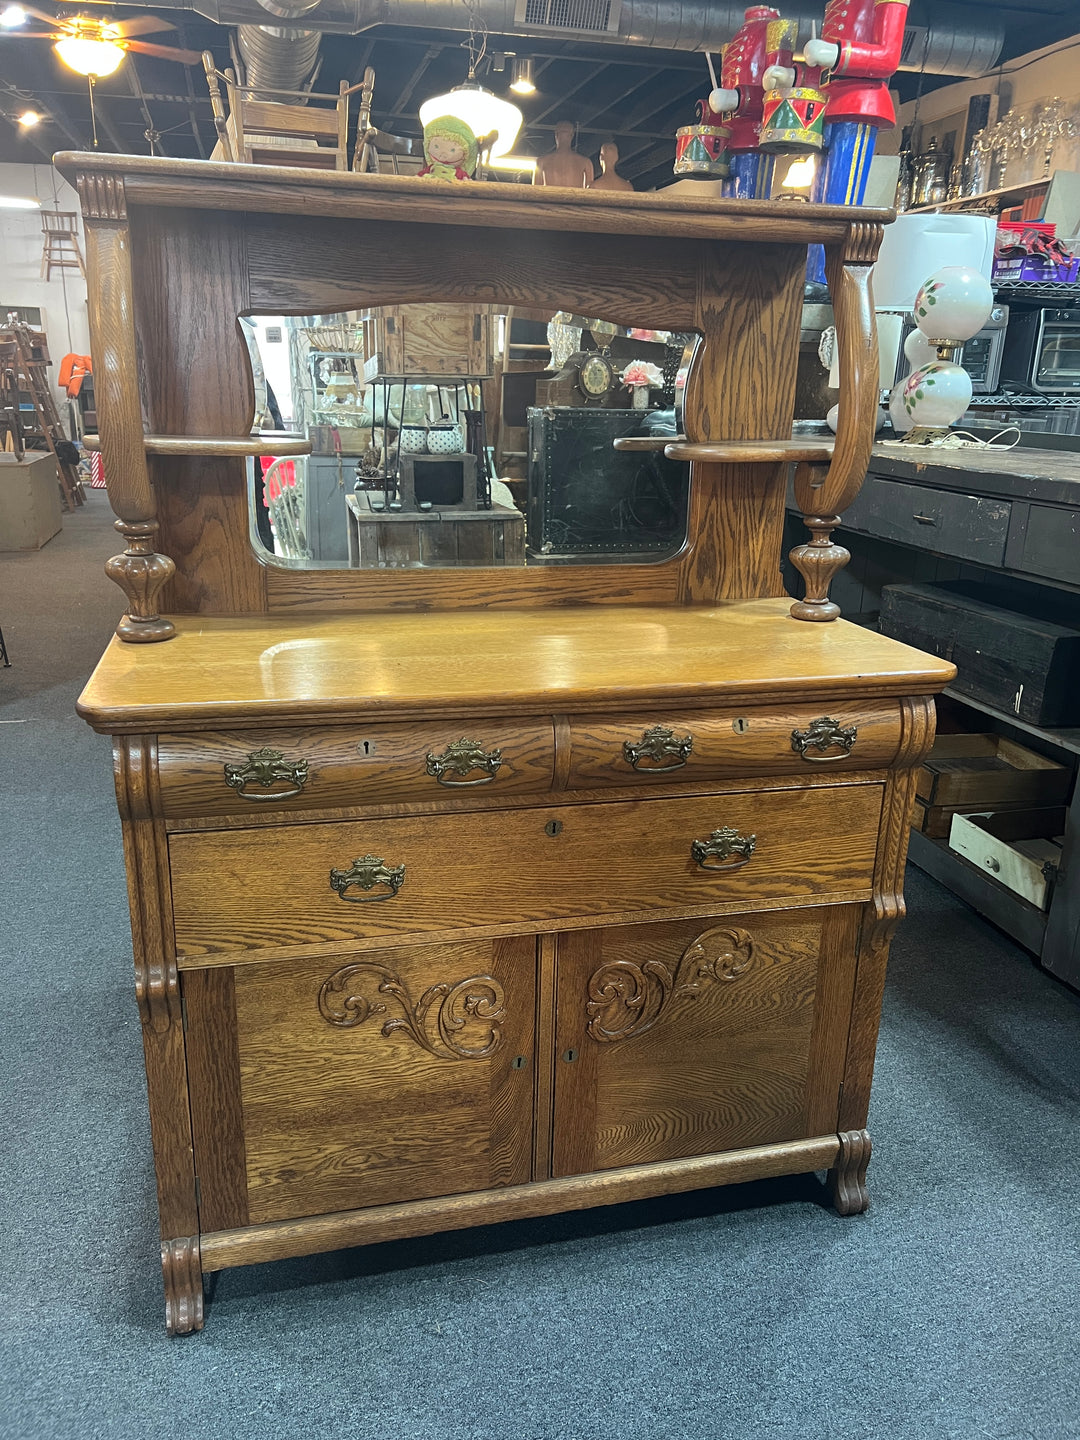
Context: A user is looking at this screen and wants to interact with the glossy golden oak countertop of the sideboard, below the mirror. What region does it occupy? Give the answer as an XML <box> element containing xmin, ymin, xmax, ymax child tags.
<box><xmin>78</xmin><ymin>598</ymin><xmax>956</xmax><ymax>732</ymax></box>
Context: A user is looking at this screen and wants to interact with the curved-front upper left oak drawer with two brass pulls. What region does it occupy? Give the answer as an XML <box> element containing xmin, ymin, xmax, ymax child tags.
<box><xmin>157</xmin><ymin>719</ymin><xmax>554</xmax><ymax>816</ymax></box>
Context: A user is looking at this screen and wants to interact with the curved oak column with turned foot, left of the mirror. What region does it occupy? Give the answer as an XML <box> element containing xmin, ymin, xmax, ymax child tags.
<box><xmin>76</xmin><ymin>174</ymin><xmax>176</xmax><ymax>642</ymax></box>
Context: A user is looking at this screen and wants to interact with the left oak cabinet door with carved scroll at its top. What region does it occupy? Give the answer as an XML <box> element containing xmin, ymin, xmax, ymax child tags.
<box><xmin>181</xmin><ymin>936</ymin><xmax>536</xmax><ymax>1231</ymax></box>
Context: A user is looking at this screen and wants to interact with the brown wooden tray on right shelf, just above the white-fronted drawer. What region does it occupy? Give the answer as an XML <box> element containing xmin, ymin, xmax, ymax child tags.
<box><xmin>916</xmin><ymin>734</ymin><xmax>1073</xmax><ymax>809</ymax></box>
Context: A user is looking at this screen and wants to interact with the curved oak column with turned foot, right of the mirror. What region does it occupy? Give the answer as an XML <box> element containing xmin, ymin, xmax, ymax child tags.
<box><xmin>791</xmin><ymin>220</ymin><xmax>884</xmax><ymax>621</ymax></box>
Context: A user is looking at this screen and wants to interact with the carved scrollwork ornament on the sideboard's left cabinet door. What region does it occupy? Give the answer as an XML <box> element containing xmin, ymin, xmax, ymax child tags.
<box><xmin>318</xmin><ymin>960</ymin><xmax>507</xmax><ymax>1060</ymax></box>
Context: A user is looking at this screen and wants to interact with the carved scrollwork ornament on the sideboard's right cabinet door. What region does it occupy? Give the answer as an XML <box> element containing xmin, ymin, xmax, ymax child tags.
<box><xmin>585</xmin><ymin>929</ymin><xmax>755</xmax><ymax>1043</ymax></box>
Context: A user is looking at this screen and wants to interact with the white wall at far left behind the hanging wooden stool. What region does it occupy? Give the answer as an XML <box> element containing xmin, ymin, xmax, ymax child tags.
<box><xmin>0</xmin><ymin>164</ymin><xmax>89</xmax><ymax>411</ymax></box>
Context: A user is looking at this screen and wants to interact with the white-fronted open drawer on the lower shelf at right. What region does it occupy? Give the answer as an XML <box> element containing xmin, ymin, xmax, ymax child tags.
<box><xmin>949</xmin><ymin>806</ymin><xmax>1066</xmax><ymax>910</ymax></box>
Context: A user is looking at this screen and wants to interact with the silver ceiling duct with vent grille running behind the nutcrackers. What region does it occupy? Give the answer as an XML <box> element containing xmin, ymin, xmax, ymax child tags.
<box><xmin>167</xmin><ymin>0</ymin><xmax>1005</xmax><ymax>78</ymax></box>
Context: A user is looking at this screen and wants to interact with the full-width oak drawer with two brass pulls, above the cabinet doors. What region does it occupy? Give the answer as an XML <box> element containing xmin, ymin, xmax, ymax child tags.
<box><xmin>170</xmin><ymin>785</ymin><xmax>881</xmax><ymax>956</ymax></box>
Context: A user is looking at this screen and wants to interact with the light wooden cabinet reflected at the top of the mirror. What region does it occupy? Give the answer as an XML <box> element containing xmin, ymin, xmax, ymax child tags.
<box><xmin>363</xmin><ymin>305</ymin><xmax>495</xmax><ymax>383</ymax></box>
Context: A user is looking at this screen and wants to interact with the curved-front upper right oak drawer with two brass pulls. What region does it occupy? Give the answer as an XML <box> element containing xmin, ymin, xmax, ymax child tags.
<box><xmin>569</xmin><ymin>701</ymin><xmax>900</xmax><ymax>788</ymax></box>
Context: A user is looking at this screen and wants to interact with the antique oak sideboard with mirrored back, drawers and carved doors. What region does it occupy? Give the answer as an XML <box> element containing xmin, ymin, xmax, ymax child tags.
<box><xmin>56</xmin><ymin>154</ymin><xmax>952</xmax><ymax>1333</ymax></box>
